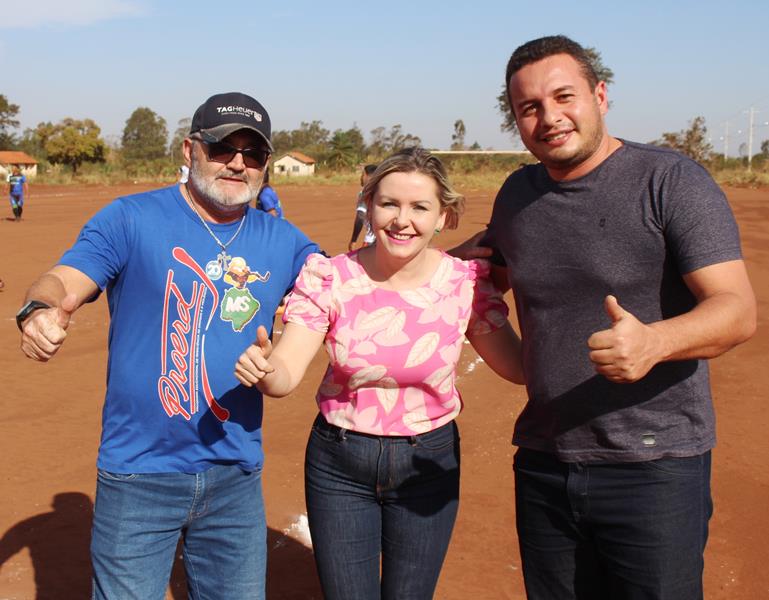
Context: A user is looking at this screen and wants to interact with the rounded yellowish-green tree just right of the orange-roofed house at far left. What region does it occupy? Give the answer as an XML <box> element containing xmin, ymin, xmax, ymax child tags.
<box><xmin>46</xmin><ymin>118</ymin><xmax>106</xmax><ymax>174</ymax></box>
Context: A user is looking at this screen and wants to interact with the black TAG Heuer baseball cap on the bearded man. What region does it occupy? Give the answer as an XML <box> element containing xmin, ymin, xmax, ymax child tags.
<box><xmin>190</xmin><ymin>92</ymin><xmax>272</xmax><ymax>151</ymax></box>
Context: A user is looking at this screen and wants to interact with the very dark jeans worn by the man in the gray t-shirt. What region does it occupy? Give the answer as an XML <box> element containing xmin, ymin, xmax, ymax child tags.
<box><xmin>514</xmin><ymin>448</ymin><xmax>713</xmax><ymax>600</ymax></box>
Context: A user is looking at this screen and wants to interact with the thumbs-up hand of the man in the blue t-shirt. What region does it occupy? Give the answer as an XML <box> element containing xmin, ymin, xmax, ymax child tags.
<box><xmin>21</xmin><ymin>294</ymin><xmax>78</xmax><ymax>362</ymax></box>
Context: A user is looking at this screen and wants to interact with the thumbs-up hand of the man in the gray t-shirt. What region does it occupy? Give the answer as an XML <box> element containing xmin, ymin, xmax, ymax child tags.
<box><xmin>587</xmin><ymin>296</ymin><xmax>660</xmax><ymax>383</ymax></box>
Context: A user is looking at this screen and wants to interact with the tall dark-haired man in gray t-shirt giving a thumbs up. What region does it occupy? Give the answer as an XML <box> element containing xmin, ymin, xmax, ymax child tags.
<box><xmin>484</xmin><ymin>36</ymin><xmax>756</xmax><ymax>600</ymax></box>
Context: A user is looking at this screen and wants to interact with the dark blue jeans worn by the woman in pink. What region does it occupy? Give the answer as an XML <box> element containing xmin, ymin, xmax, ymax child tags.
<box><xmin>305</xmin><ymin>416</ymin><xmax>459</xmax><ymax>600</ymax></box>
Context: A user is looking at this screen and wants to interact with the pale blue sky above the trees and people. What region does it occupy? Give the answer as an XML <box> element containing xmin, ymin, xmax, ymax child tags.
<box><xmin>0</xmin><ymin>0</ymin><xmax>769</xmax><ymax>156</ymax></box>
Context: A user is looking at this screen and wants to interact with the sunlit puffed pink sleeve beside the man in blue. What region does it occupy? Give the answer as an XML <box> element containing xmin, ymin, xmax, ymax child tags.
<box><xmin>283</xmin><ymin>254</ymin><xmax>334</xmax><ymax>333</ymax></box>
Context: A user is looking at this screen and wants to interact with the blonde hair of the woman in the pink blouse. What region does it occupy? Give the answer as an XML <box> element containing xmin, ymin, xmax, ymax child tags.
<box><xmin>361</xmin><ymin>146</ymin><xmax>465</xmax><ymax>229</ymax></box>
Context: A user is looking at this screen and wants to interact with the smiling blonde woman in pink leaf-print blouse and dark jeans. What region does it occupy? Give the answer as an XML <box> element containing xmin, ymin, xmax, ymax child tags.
<box><xmin>235</xmin><ymin>148</ymin><xmax>523</xmax><ymax>600</ymax></box>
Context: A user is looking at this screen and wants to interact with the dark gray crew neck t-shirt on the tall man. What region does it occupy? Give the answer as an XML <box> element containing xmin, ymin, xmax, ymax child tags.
<box><xmin>485</xmin><ymin>141</ymin><xmax>742</xmax><ymax>462</ymax></box>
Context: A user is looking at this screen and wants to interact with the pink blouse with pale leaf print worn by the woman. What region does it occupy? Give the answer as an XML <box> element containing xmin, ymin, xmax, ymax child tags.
<box><xmin>283</xmin><ymin>252</ymin><xmax>508</xmax><ymax>435</ymax></box>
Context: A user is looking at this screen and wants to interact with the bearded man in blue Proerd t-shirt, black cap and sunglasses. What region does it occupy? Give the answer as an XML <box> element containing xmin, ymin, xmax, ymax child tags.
<box><xmin>17</xmin><ymin>93</ymin><xmax>318</xmax><ymax>599</ymax></box>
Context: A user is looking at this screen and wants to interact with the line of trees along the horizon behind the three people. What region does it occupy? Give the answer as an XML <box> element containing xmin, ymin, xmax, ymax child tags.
<box><xmin>0</xmin><ymin>55</ymin><xmax>769</xmax><ymax>179</ymax></box>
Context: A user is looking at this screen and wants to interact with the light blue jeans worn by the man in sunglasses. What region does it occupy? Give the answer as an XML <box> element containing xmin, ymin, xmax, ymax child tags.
<box><xmin>91</xmin><ymin>465</ymin><xmax>267</xmax><ymax>600</ymax></box>
